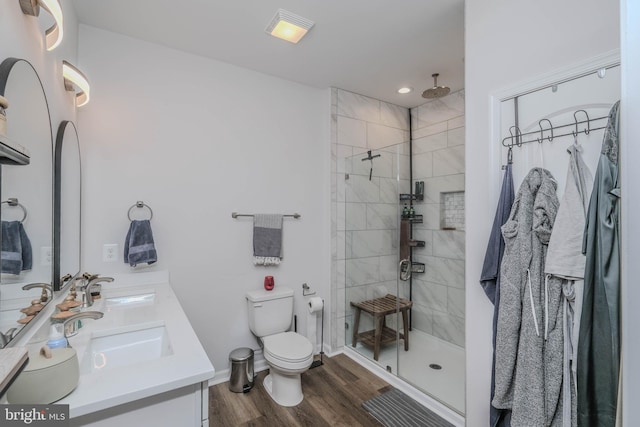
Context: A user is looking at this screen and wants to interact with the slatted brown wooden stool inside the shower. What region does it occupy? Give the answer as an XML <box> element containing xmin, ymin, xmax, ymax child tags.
<box><xmin>351</xmin><ymin>294</ymin><xmax>413</xmax><ymax>360</ymax></box>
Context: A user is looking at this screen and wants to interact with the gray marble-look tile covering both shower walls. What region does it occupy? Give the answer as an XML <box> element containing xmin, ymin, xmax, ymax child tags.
<box><xmin>331</xmin><ymin>88</ymin><xmax>465</xmax><ymax>349</ymax></box>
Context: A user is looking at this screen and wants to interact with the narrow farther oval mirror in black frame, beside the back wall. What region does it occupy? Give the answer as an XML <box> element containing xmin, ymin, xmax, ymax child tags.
<box><xmin>53</xmin><ymin>120</ymin><xmax>82</xmax><ymax>291</ymax></box>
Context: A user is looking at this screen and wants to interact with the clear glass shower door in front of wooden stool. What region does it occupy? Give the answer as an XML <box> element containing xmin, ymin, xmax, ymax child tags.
<box><xmin>344</xmin><ymin>143</ymin><xmax>410</xmax><ymax>373</ymax></box>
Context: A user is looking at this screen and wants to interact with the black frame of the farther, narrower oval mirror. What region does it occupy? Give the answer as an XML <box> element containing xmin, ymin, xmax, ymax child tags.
<box><xmin>53</xmin><ymin>120</ymin><xmax>82</xmax><ymax>291</ymax></box>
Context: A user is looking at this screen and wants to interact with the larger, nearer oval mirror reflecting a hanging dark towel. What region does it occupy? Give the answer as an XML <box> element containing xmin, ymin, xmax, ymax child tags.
<box><xmin>0</xmin><ymin>58</ymin><xmax>53</xmax><ymax>345</ymax></box>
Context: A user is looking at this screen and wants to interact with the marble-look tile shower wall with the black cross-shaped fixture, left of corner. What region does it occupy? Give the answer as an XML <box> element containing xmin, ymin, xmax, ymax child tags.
<box><xmin>331</xmin><ymin>89</ymin><xmax>410</xmax><ymax>348</ymax></box>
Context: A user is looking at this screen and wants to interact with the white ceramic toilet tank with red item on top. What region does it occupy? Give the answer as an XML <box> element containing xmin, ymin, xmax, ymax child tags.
<box><xmin>246</xmin><ymin>286</ymin><xmax>293</xmax><ymax>337</ymax></box>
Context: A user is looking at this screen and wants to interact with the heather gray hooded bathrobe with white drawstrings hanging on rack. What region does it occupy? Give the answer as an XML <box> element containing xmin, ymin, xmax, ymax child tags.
<box><xmin>492</xmin><ymin>168</ymin><xmax>563</xmax><ymax>427</ymax></box>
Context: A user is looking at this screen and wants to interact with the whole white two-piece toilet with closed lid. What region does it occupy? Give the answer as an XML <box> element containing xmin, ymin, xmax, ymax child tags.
<box><xmin>247</xmin><ymin>286</ymin><xmax>313</xmax><ymax>406</ymax></box>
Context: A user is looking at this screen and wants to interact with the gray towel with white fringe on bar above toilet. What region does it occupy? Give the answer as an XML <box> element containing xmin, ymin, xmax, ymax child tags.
<box><xmin>253</xmin><ymin>214</ymin><xmax>282</xmax><ymax>265</ymax></box>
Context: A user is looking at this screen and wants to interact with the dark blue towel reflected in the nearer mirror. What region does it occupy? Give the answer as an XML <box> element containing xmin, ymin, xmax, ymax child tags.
<box><xmin>0</xmin><ymin>221</ymin><xmax>33</xmax><ymax>275</ymax></box>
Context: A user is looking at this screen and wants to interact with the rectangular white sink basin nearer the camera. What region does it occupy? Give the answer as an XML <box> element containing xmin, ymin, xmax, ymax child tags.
<box><xmin>80</xmin><ymin>323</ymin><xmax>173</xmax><ymax>374</ymax></box>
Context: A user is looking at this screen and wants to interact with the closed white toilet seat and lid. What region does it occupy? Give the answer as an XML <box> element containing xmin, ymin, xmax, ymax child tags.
<box><xmin>263</xmin><ymin>332</ymin><xmax>313</xmax><ymax>369</ymax></box>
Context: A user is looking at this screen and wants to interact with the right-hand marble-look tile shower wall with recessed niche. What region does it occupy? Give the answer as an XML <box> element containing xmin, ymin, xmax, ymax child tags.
<box><xmin>411</xmin><ymin>91</ymin><xmax>465</xmax><ymax>346</ymax></box>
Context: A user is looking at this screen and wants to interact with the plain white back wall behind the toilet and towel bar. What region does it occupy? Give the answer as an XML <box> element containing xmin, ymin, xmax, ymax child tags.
<box><xmin>79</xmin><ymin>25</ymin><xmax>330</xmax><ymax>372</ymax></box>
